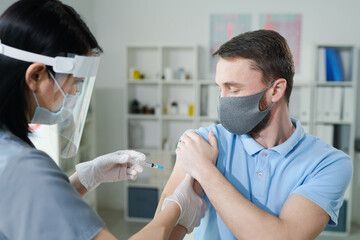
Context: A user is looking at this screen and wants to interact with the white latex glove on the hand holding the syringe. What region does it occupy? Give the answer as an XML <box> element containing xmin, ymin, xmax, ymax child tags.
<box><xmin>75</xmin><ymin>150</ymin><xmax>146</xmax><ymax>191</ymax></box>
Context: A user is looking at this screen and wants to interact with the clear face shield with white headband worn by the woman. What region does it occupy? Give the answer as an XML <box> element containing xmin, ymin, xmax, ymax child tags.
<box><xmin>0</xmin><ymin>42</ymin><xmax>100</xmax><ymax>158</ymax></box>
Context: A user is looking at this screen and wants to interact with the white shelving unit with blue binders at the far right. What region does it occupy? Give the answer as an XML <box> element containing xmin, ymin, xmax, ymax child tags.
<box><xmin>312</xmin><ymin>45</ymin><xmax>358</xmax><ymax>236</ymax></box>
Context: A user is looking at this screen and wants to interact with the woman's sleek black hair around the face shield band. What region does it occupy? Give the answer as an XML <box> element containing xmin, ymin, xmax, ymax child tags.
<box><xmin>0</xmin><ymin>0</ymin><xmax>102</xmax><ymax>145</ymax></box>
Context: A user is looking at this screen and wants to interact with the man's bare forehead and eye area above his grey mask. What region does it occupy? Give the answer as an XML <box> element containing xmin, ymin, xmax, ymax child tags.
<box><xmin>216</xmin><ymin>58</ymin><xmax>263</xmax><ymax>87</ymax></box>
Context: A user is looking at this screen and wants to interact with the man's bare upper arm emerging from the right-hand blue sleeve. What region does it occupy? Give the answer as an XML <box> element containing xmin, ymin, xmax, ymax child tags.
<box><xmin>279</xmin><ymin>194</ymin><xmax>330</xmax><ymax>239</ymax></box>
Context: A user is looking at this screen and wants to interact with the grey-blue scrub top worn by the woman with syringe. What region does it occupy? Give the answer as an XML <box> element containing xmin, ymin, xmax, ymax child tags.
<box><xmin>0</xmin><ymin>130</ymin><xmax>105</xmax><ymax>239</ymax></box>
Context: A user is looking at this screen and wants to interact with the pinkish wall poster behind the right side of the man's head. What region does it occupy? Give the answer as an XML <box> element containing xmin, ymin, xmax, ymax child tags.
<box><xmin>259</xmin><ymin>14</ymin><xmax>301</xmax><ymax>73</ymax></box>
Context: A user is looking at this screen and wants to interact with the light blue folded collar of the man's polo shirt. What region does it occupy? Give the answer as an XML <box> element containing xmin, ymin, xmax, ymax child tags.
<box><xmin>240</xmin><ymin>118</ymin><xmax>305</xmax><ymax>157</ymax></box>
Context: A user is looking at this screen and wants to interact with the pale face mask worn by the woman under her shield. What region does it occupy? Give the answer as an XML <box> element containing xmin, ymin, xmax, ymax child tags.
<box><xmin>30</xmin><ymin>72</ymin><xmax>80</xmax><ymax>125</ymax></box>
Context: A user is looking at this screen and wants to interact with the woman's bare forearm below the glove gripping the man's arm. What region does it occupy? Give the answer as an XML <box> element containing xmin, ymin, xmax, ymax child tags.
<box><xmin>130</xmin><ymin>202</ymin><xmax>186</xmax><ymax>240</ymax></box>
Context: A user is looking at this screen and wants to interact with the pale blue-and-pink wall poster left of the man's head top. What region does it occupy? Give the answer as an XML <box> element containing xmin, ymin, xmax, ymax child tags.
<box><xmin>210</xmin><ymin>14</ymin><xmax>251</xmax><ymax>75</ymax></box>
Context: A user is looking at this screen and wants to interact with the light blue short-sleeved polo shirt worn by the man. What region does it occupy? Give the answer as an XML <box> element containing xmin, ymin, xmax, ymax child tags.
<box><xmin>195</xmin><ymin>119</ymin><xmax>353</xmax><ymax>240</ymax></box>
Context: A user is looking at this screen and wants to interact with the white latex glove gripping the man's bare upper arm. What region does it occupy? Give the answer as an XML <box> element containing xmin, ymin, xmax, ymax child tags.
<box><xmin>161</xmin><ymin>174</ymin><xmax>209</xmax><ymax>233</ymax></box>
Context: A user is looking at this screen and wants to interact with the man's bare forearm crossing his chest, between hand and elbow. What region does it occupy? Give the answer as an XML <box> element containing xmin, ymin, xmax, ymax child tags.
<box><xmin>198</xmin><ymin>166</ymin><xmax>288</xmax><ymax>239</ymax></box>
